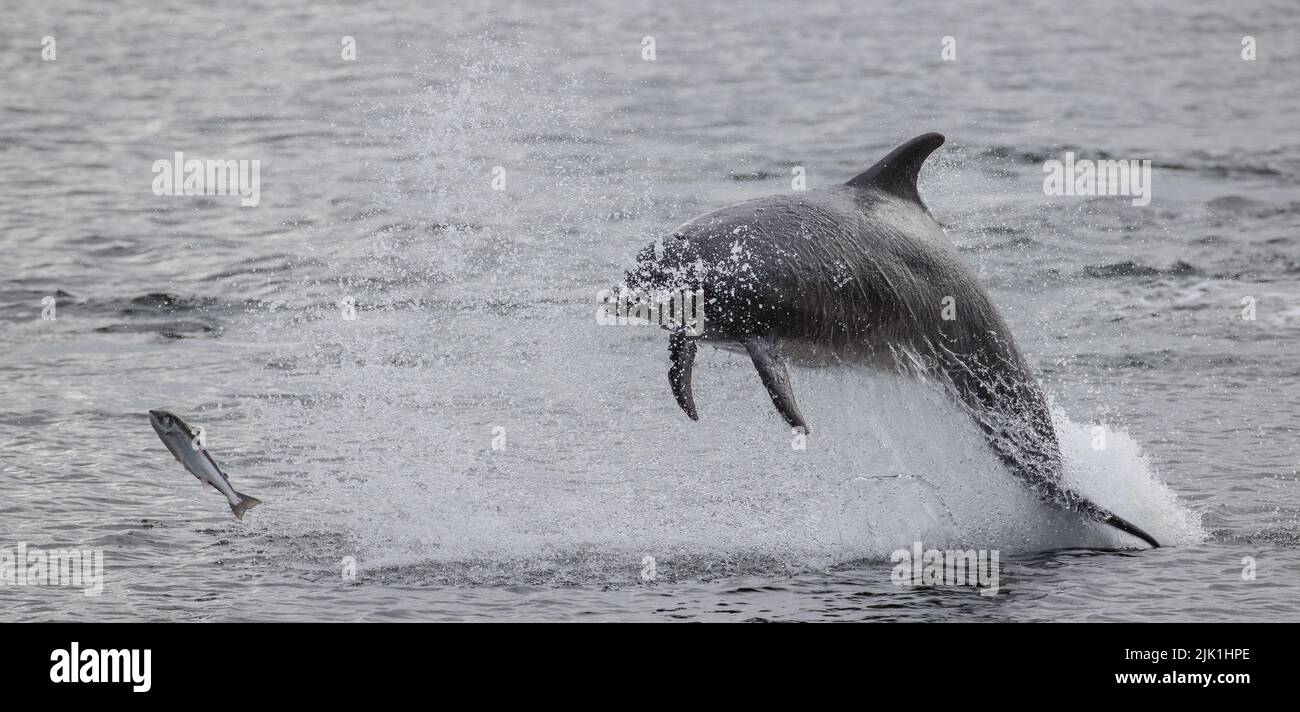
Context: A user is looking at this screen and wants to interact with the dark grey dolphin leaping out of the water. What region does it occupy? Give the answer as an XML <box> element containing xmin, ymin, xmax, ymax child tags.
<box><xmin>625</xmin><ymin>134</ymin><xmax>1160</xmax><ymax>547</ymax></box>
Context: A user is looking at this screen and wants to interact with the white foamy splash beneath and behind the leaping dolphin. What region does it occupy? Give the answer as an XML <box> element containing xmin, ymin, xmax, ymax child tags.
<box><xmin>260</xmin><ymin>324</ymin><xmax>1201</xmax><ymax>576</ymax></box>
